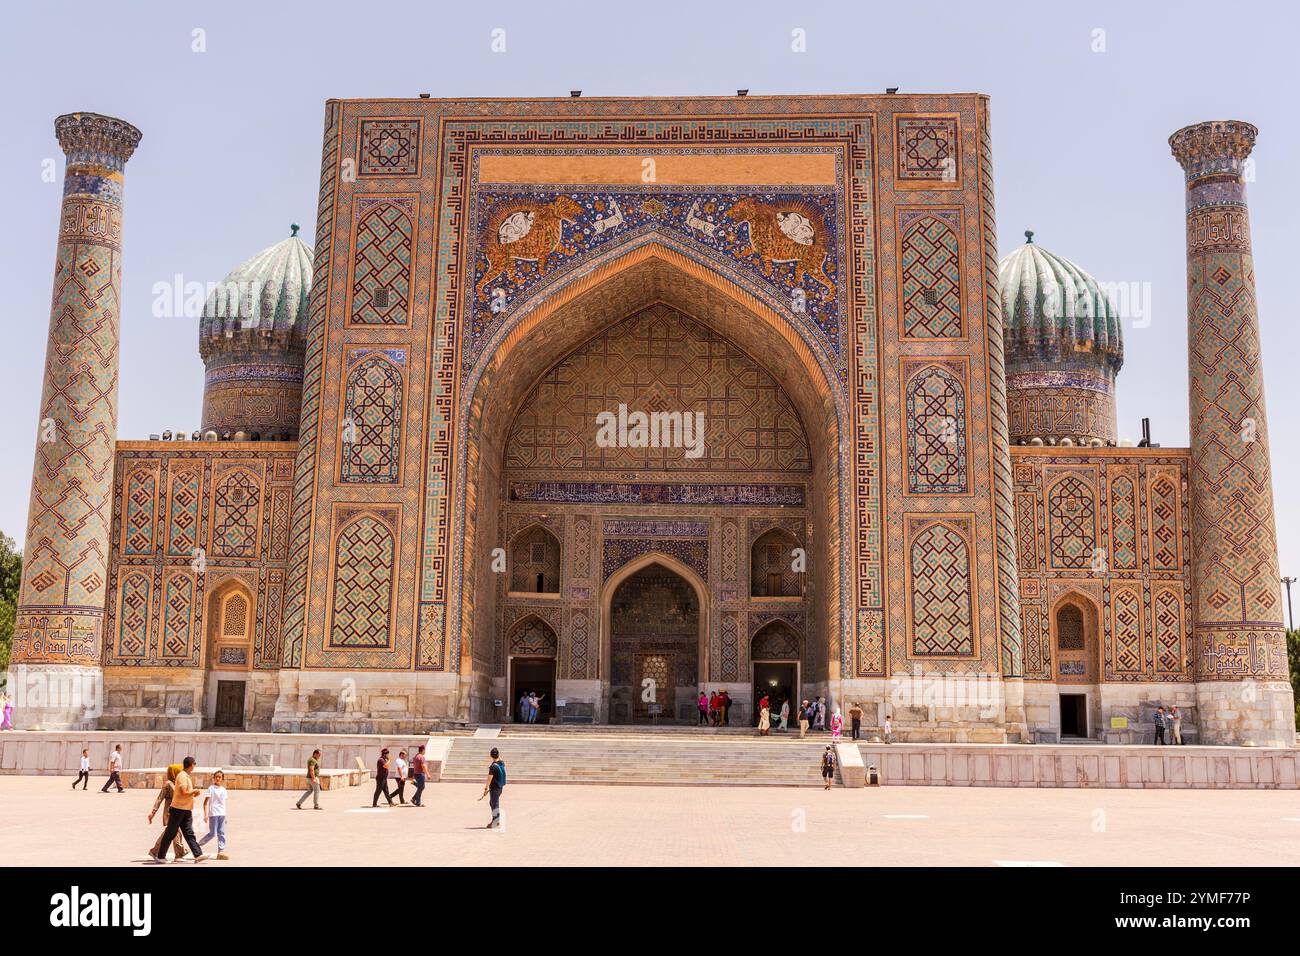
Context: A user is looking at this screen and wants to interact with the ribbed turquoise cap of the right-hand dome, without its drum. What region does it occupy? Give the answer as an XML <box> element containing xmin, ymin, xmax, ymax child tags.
<box><xmin>997</xmin><ymin>233</ymin><xmax>1125</xmax><ymax>375</ymax></box>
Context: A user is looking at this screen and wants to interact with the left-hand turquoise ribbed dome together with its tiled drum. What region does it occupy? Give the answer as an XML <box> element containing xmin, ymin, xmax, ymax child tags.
<box><xmin>199</xmin><ymin>225</ymin><xmax>312</xmax><ymax>438</ymax></box>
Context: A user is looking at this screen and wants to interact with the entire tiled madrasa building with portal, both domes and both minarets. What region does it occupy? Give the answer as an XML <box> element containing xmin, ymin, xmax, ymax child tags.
<box><xmin>13</xmin><ymin>94</ymin><xmax>1295</xmax><ymax>745</ymax></box>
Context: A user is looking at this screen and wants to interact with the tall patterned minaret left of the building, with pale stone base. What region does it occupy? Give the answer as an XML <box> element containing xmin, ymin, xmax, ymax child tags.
<box><xmin>12</xmin><ymin>113</ymin><xmax>140</xmax><ymax>730</ymax></box>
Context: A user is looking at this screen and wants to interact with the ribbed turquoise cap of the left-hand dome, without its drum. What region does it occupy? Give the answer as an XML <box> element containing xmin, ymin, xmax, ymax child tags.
<box><xmin>199</xmin><ymin>226</ymin><xmax>312</xmax><ymax>359</ymax></box>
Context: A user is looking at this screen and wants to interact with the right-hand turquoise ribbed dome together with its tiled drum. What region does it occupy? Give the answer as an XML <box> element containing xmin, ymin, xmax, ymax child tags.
<box><xmin>997</xmin><ymin>232</ymin><xmax>1125</xmax><ymax>445</ymax></box>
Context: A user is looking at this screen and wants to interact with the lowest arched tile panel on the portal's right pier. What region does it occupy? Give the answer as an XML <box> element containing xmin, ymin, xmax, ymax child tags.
<box><xmin>910</xmin><ymin>522</ymin><xmax>975</xmax><ymax>656</ymax></box>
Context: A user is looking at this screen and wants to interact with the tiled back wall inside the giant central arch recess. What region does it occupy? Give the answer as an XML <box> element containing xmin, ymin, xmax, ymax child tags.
<box><xmin>467</xmin><ymin>267</ymin><xmax>837</xmax><ymax>724</ymax></box>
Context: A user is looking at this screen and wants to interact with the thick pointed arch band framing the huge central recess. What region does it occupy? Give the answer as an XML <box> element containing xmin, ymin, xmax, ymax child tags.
<box><xmin>449</xmin><ymin>243</ymin><xmax>850</xmax><ymax>723</ymax></box>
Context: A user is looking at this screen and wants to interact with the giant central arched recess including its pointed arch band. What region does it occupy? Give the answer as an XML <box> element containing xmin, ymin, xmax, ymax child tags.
<box><xmin>451</xmin><ymin>242</ymin><xmax>849</xmax><ymax>721</ymax></box>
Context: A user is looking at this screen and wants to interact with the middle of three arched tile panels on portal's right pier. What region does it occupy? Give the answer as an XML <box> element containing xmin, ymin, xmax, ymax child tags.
<box><xmin>907</xmin><ymin>365</ymin><xmax>970</xmax><ymax>494</ymax></box>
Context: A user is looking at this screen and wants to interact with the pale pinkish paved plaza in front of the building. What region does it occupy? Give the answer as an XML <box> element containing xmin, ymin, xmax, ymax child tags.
<box><xmin>0</xmin><ymin>775</ymin><xmax>1300</xmax><ymax>870</ymax></box>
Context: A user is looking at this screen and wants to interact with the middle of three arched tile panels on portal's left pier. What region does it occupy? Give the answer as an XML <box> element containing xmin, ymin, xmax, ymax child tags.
<box><xmin>339</xmin><ymin>352</ymin><xmax>402</xmax><ymax>484</ymax></box>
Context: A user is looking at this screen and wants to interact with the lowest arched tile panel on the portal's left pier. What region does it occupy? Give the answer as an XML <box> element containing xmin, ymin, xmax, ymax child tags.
<box><xmin>330</xmin><ymin>515</ymin><xmax>394</xmax><ymax>648</ymax></box>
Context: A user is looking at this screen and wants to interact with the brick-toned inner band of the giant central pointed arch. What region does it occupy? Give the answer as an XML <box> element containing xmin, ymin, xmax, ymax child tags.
<box><xmin>452</xmin><ymin>235</ymin><xmax>847</xmax><ymax>674</ymax></box>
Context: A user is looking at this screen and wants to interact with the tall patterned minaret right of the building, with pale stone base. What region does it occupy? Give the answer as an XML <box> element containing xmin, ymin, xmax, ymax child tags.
<box><xmin>1169</xmin><ymin>120</ymin><xmax>1295</xmax><ymax>747</ymax></box>
